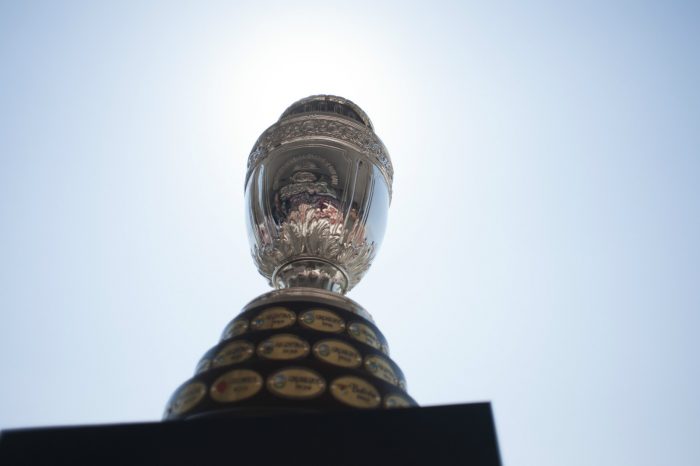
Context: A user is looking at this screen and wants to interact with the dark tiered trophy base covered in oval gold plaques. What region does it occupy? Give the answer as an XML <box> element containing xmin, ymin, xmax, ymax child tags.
<box><xmin>163</xmin><ymin>288</ymin><xmax>417</xmax><ymax>420</ymax></box>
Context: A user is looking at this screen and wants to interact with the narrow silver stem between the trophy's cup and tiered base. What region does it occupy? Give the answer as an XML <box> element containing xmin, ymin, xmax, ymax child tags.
<box><xmin>272</xmin><ymin>257</ymin><xmax>348</xmax><ymax>294</ymax></box>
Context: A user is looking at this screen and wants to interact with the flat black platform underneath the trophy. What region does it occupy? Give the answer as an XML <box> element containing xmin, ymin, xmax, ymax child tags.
<box><xmin>0</xmin><ymin>403</ymin><xmax>501</xmax><ymax>466</ymax></box>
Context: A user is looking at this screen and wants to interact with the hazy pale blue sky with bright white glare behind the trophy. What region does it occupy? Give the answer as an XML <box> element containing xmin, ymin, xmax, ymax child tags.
<box><xmin>0</xmin><ymin>0</ymin><xmax>700</xmax><ymax>466</ymax></box>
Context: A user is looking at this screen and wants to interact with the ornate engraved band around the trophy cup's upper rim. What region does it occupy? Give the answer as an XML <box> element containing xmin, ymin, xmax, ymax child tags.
<box><xmin>246</xmin><ymin>114</ymin><xmax>394</xmax><ymax>197</ymax></box>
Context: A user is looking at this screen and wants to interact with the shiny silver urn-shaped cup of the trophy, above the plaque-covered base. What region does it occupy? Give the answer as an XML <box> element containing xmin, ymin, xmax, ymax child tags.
<box><xmin>245</xmin><ymin>96</ymin><xmax>393</xmax><ymax>294</ymax></box>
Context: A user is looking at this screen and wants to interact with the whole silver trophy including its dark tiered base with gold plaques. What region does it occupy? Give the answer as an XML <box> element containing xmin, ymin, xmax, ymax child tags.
<box><xmin>164</xmin><ymin>95</ymin><xmax>416</xmax><ymax>419</ymax></box>
